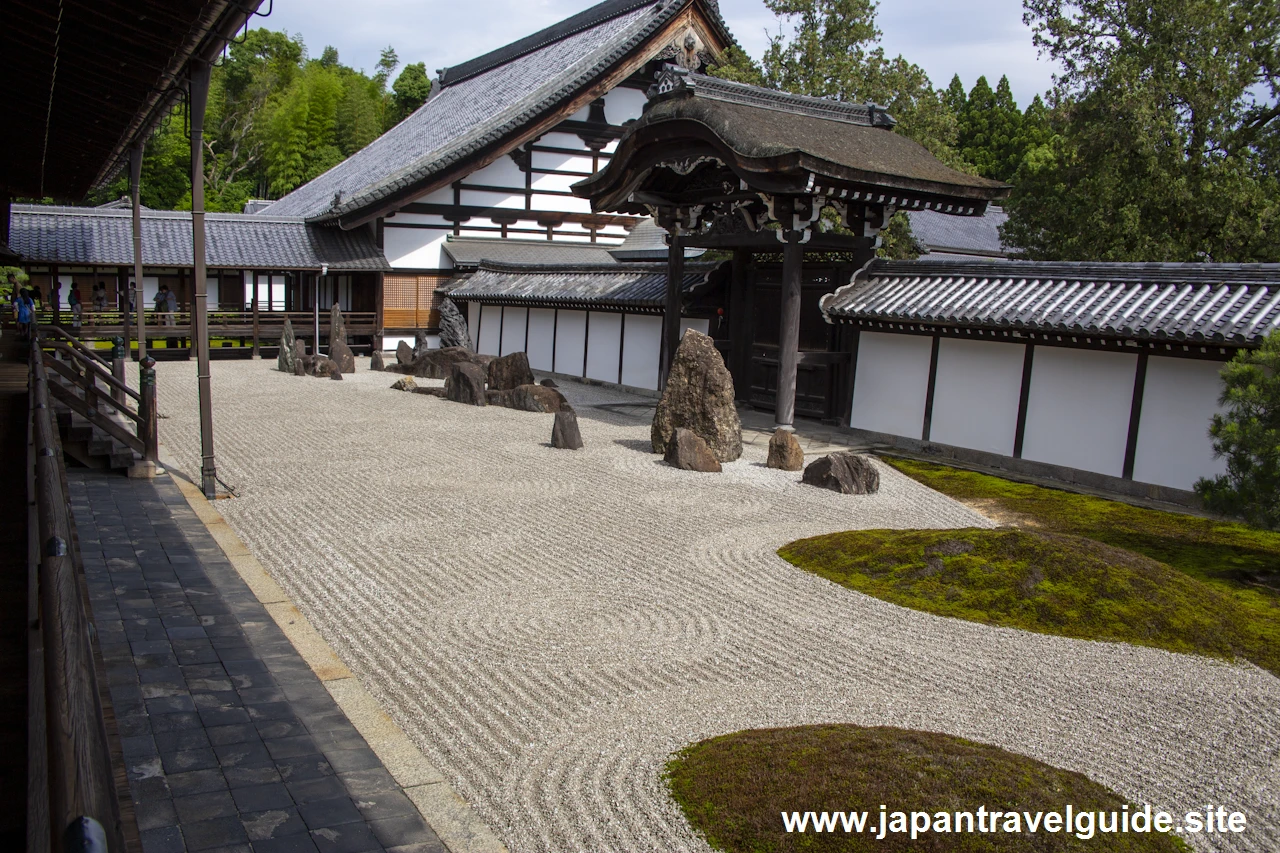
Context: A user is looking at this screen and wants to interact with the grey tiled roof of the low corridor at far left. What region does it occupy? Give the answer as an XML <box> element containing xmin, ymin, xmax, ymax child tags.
<box><xmin>9</xmin><ymin>205</ymin><xmax>390</xmax><ymax>272</ymax></box>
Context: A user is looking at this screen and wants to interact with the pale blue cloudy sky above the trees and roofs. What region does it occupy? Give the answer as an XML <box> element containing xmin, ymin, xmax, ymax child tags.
<box><xmin>255</xmin><ymin>0</ymin><xmax>1053</xmax><ymax>106</ymax></box>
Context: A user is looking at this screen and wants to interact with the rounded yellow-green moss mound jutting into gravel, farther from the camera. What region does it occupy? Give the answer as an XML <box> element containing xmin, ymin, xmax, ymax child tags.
<box><xmin>778</xmin><ymin>528</ymin><xmax>1280</xmax><ymax>672</ymax></box>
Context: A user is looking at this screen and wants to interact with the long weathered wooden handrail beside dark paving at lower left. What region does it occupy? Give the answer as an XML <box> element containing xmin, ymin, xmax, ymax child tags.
<box><xmin>28</xmin><ymin>327</ymin><xmax>124</xmax><ymax>853</ymax></box>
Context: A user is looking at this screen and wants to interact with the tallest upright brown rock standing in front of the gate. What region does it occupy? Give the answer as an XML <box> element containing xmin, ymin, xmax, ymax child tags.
<box><xmin>650</xmin><ymin>329</ymin><xmax>742</xmax><ymax>462</ymax></box>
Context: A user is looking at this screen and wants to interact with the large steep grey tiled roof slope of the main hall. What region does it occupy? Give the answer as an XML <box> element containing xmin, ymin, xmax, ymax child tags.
<box><xmin>259</xmin><ymin>0</ymin><xmax>731</xmax><ymax>219</ymax></box>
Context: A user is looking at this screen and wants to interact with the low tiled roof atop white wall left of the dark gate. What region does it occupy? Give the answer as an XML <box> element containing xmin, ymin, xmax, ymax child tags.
<box><xmin>449</xmin><ymin>263</ymin><xmax>716</xmax><ymax>310</ymax></box>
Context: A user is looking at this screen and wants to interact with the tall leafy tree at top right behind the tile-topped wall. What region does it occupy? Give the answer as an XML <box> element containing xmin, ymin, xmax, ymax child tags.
<box><xmin>1004</xmin><ymin>0</ymin><xmax>1280</xmax><ymax>261</ymax></box>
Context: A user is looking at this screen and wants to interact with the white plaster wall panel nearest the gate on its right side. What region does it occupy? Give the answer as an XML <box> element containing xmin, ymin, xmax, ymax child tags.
<box><xmin>849</xmin><ymin>332</ymin><xmax>933</xmax><ymax>439</ymax></box>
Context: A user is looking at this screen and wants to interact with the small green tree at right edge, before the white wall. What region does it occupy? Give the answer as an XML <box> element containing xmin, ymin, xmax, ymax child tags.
<box><xmin>1196</xmin><ymin>332</ymin><xmax>1280</xmax><ymax>529</ymax></box>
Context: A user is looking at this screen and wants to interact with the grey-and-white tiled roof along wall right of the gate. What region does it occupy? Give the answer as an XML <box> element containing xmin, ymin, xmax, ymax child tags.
<box><xmin>822</xmin><ymin>260</ymin><xmax>1280</xmax><ymax>345</ymax></box>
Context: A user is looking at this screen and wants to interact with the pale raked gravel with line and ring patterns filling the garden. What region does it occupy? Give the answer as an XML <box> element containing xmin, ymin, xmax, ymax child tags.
<box><xmin>159</xmin><ymin>361</ymin><xmax>1280</xmax><ymax>853</ymax></box>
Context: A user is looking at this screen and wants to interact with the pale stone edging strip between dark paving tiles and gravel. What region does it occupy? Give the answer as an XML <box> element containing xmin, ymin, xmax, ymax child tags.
<box><xmin>161</xmin><ymin>451</ymin><xmax>508</xmax><ymax>853</ymax></box>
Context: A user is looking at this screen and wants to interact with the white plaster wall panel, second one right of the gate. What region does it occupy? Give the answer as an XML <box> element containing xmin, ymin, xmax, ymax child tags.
<box><xmin>926</xmin><ymin>338</ymin><xmax>1027</xmax><ymax>456</ymax></box>
